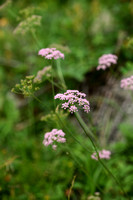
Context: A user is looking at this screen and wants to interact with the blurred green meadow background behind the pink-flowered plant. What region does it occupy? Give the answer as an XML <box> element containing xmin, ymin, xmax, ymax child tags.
<box><xmin>0</xmin><ymin>0</ymin><xmax>133</xmax><ymax>200</ymax></box>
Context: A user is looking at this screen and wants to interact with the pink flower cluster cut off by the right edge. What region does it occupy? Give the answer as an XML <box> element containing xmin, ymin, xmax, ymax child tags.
<box><xmin>121</xmin><ymin>76</ymin><xmax>133</xmax><ymax>90</ymax></box>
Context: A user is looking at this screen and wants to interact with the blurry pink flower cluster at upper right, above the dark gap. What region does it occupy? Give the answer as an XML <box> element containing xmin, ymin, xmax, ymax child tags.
<box><xmin>97</xmin><ymin>54</ymin><xmax>118</xmax><ymax>70</ymax></box>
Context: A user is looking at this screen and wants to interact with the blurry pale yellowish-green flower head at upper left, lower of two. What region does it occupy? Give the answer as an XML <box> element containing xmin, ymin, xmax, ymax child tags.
<box><xmin>14</xmin><ymin>15</ymin><xmax>42</xmax><ymax>35</ymax></box>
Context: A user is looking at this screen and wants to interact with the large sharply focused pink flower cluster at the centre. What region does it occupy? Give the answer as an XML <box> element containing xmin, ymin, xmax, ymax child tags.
<box><xmin>54</xmin><ymin>90</ymin><xmax>90</xmax><ymax>114</ymax></box>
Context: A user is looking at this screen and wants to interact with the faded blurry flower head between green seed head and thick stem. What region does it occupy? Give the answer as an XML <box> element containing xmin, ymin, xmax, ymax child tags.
<box><xmin>34</xmin><ymin>66</ymin><xmax>51</xmax><ymax>83</ymax></box>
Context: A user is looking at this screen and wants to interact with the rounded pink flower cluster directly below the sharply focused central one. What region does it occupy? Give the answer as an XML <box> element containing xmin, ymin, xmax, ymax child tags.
<box><xmin>43</xmin><ymin>129</ymin><xmax>66</xmax><ymax>150</ymax></box>
